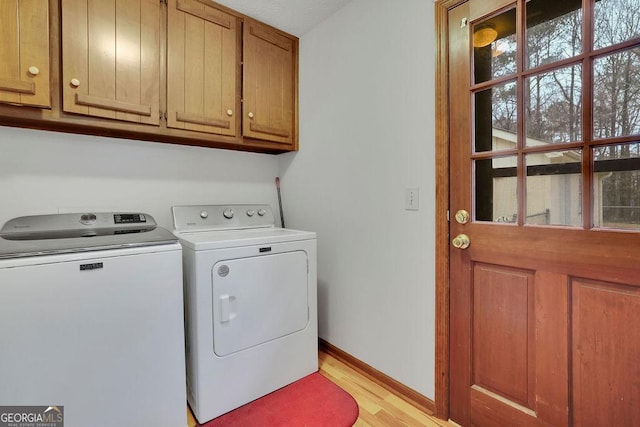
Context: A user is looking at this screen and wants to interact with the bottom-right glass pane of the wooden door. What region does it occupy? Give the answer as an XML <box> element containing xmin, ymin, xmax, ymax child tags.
<box><xmin>593</xmin><ymin>142</ymin><xmax>640</xmax><ymax>229</ymax></box>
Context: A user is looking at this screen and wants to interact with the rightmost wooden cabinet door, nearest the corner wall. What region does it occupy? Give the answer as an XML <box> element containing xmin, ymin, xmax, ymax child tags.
<box><xmin>242</xmin><ymin>19</ymin><xmax>297</xmax><ymax>145</ymax></box>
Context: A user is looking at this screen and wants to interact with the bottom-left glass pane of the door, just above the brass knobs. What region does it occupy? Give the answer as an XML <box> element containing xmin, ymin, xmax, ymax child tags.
<box><xmin>474</xmin><ymin>156</ymin><xmax>518</xmax><ymax>223</ymax></box>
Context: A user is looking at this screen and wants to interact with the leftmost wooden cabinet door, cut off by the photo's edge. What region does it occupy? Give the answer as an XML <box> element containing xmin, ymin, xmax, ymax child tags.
<box><xmin>0</xmin><ymin>0</ymin><xmax>51</xmax><ymax>107</ymax></box>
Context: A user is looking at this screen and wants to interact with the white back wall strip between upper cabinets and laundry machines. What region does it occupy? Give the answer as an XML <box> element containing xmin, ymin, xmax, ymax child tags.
<box><xmin>0</xmin><ymin>127</ymin><xmax>278</xmax><ymax>229</ymax></box>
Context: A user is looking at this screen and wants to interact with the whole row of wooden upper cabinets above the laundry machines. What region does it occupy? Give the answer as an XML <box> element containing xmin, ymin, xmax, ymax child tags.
<box><xmin>0</xmin><ymin>0</ymin><xmax>298</xmax><ymax>153</ymax></box>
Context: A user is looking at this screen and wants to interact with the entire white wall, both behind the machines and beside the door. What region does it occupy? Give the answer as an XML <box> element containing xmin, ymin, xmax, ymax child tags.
<box><xmin>0</xmin><ymin>0</ymin><xmax>435</xmax><ymax>399</ymax></box>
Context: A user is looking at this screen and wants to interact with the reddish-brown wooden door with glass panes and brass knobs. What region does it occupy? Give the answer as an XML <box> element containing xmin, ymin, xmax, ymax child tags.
<box><xmin>448</xmin><ymin>0</ymin><xmax>640</xmax><ymax>426</ymax></box>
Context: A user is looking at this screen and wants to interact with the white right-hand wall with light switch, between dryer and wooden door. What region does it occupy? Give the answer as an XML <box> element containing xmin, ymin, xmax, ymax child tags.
<box><xmin>280</xmin><ymin>0</ymin><xmax>435</xmax><ymax>399</ymax></box>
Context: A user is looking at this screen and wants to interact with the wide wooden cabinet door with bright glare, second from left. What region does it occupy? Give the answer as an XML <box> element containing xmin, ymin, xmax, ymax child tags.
<box><xmin>62</xmin><ymin>0</ymin><xmax>160</xmax><ymax>125</ymax></box>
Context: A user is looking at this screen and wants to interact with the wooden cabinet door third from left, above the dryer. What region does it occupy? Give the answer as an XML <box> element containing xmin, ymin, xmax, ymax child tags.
<box><xmin>167</xmin><ymin>0</ymin><xmax>239</xmax><ymax>136</ymax></box>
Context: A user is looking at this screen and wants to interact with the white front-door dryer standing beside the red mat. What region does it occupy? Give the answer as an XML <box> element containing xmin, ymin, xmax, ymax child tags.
<box><xmin>173</xmin><ymin>205</ymin><xmax>318</xmax><ymax>423</ymax></box>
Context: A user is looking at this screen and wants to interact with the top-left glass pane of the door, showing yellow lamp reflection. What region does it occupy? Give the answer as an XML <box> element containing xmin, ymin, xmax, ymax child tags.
<box><xmin>473</xmin><ymin>9</ymin><xmax>516</xmax><ymax>83</ymax></box>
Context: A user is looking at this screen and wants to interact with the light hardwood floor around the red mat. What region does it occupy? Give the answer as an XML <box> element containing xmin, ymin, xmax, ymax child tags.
<box><xmin>187</xmin><ymin>350</ymin><xmax>455</xmax><ymax>427</ymax></box>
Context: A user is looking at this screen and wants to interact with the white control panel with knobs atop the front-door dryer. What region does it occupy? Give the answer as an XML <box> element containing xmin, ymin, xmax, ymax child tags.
<box><xmin>171</xmin><ymin>205</ymin><xmax>275</xmax><ymax>232</ymax></box>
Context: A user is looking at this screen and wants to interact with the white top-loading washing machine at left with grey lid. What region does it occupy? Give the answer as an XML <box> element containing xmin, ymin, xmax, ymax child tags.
<box><xmin>0</xmin><ymin>213</ymin><xmax>187</xmax><ymax>427</ymax></box>
